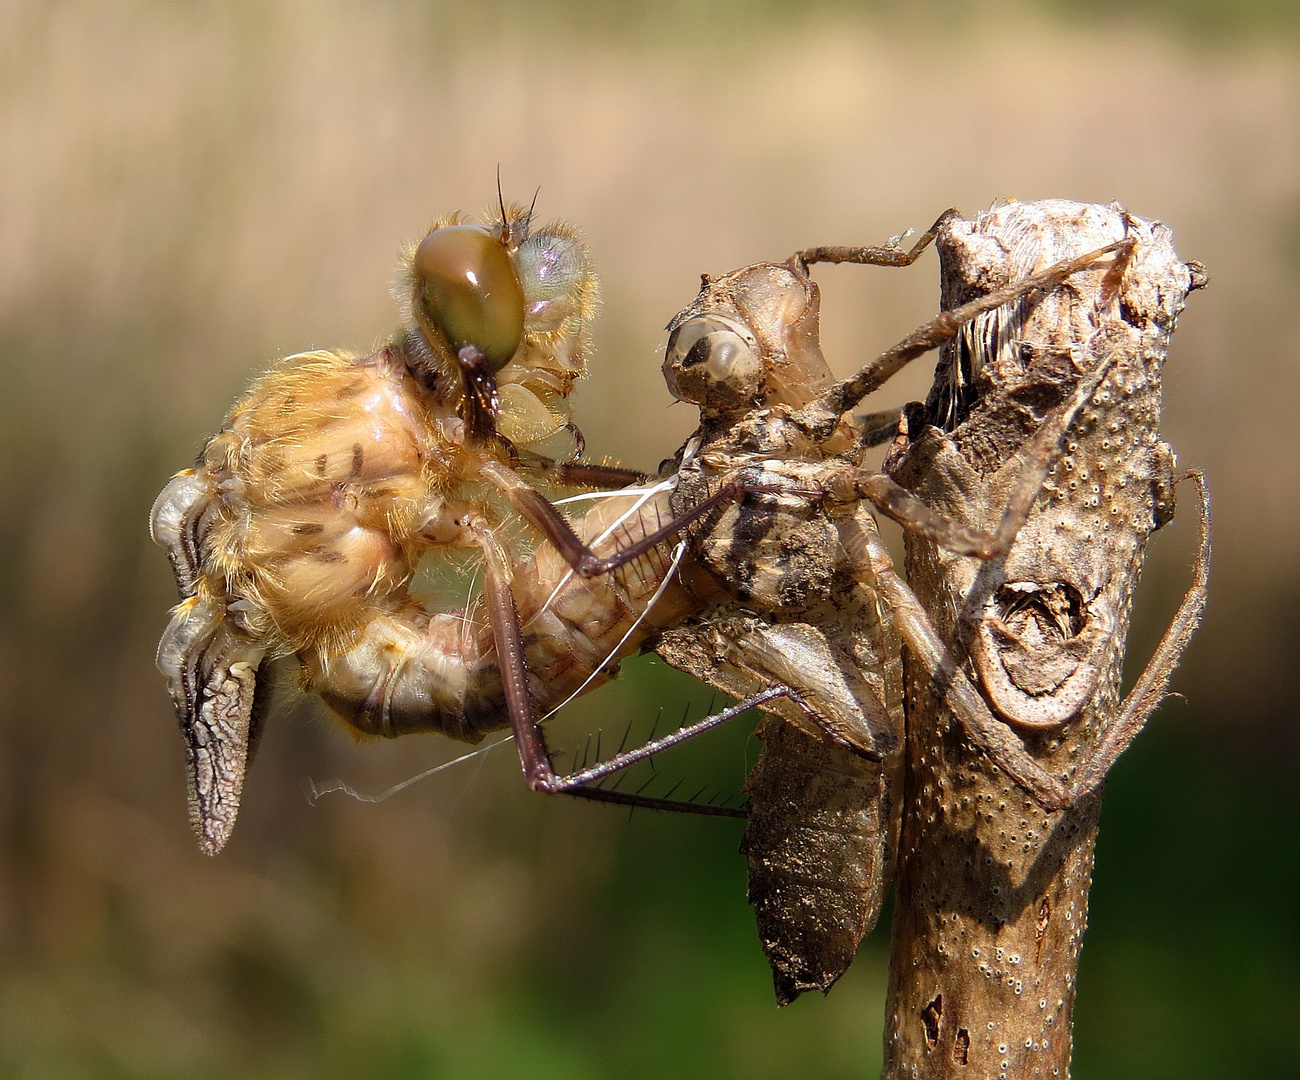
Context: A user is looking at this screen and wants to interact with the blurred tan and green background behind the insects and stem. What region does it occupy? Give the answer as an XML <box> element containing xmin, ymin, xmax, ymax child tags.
<box><xmin>0</xmin><ymin>0</ymin><xmax>1300</xmax><ymax>1080</ymax></box>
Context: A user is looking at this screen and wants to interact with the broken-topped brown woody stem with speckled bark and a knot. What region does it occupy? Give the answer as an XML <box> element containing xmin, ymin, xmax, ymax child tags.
<box><xmin>883</xmin><ymin>201</ymin><xmax>1204</xmax><ymax>1080</ymax></box>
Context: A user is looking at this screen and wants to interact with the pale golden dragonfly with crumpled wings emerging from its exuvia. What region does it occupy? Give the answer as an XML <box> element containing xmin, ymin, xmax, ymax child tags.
<box><xmin>151</xmin><ymin>194</ymin><xmax>698</xmax><ymax>853</ymax></box>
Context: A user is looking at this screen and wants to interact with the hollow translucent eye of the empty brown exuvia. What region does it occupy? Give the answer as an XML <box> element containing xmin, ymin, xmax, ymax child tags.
<box><xmin>663</xmin><ymin>316</ymin><xmax>764</xmax><ymax>409</ymax></box>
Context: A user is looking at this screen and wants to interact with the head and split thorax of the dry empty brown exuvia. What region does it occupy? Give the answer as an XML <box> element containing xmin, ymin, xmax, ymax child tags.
<box><xmin>663</xmin><ymin>260</ymin><xmax>862</xmax><ymax>619</ymax></box>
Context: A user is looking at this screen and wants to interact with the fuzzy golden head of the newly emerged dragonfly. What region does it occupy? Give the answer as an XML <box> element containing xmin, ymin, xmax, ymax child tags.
<box><xmin>395</xmin><ymin>207</ymin><xmax>599</xmax><ymax>446</ymax></box>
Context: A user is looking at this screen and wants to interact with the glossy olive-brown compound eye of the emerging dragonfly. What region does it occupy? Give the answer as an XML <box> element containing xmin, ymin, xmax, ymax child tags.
<box><xmin>413</xmin><ymin>225</ymin><xmax>524</xmax><ymax>370</ymax></box>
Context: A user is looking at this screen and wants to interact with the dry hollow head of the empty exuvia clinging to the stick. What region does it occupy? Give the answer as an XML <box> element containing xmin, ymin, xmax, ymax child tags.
<box><xmin>663</xmin><ymin>259</ymin><xmax>854</xmax><ymax>456</ymax></box>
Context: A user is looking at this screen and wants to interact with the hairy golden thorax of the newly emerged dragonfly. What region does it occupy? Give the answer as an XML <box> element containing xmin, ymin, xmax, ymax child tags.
<box><xmin>200</xmin><ymin>346</ymin><xmax>482</xmax><ymax>652</ymax></box>
